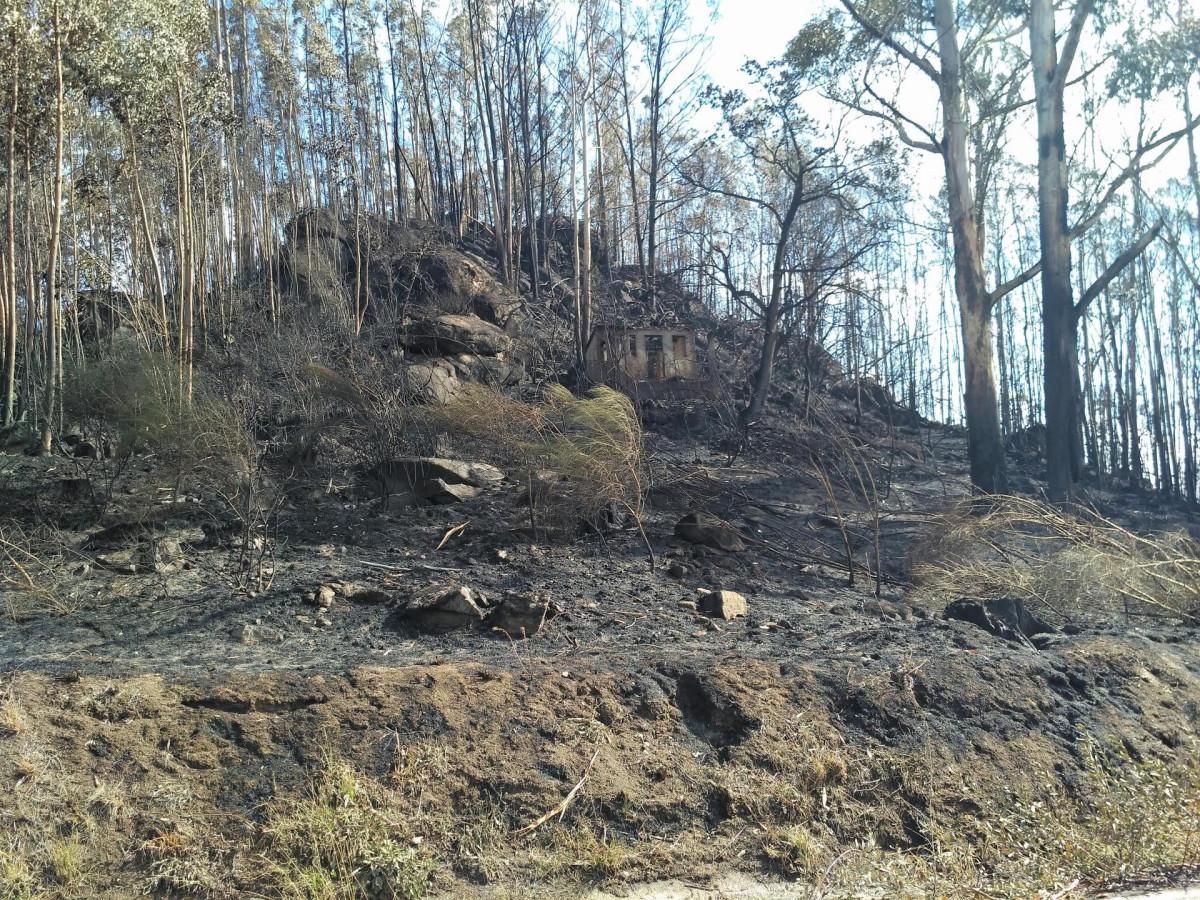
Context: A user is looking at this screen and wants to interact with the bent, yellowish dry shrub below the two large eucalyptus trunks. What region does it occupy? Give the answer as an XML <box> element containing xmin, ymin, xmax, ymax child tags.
<box><xmin>912</xmin><ymin>497</ymin><xmax>1200</xmax><ymax>624</ymax></box>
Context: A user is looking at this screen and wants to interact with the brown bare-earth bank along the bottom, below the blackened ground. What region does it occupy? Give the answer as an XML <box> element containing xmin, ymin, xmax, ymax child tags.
<box><xmin>0</xmin><ymin>625</ymin><xmax>1200</xmax><ymax>898</ymax></box>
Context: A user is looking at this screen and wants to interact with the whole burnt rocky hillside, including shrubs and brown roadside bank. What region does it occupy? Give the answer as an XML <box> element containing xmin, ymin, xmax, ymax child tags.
<box><xmin>0</xmin><ymin>220</ymin><xmax>1200</xmax><ymax>899</ymax></box>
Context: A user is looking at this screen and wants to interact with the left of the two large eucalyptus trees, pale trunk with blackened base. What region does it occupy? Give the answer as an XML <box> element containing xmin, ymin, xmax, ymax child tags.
<box><xmin>787</xmin><ymin>0</ymin><xmax>1032</xmax><ymax>493</ymax></box>
